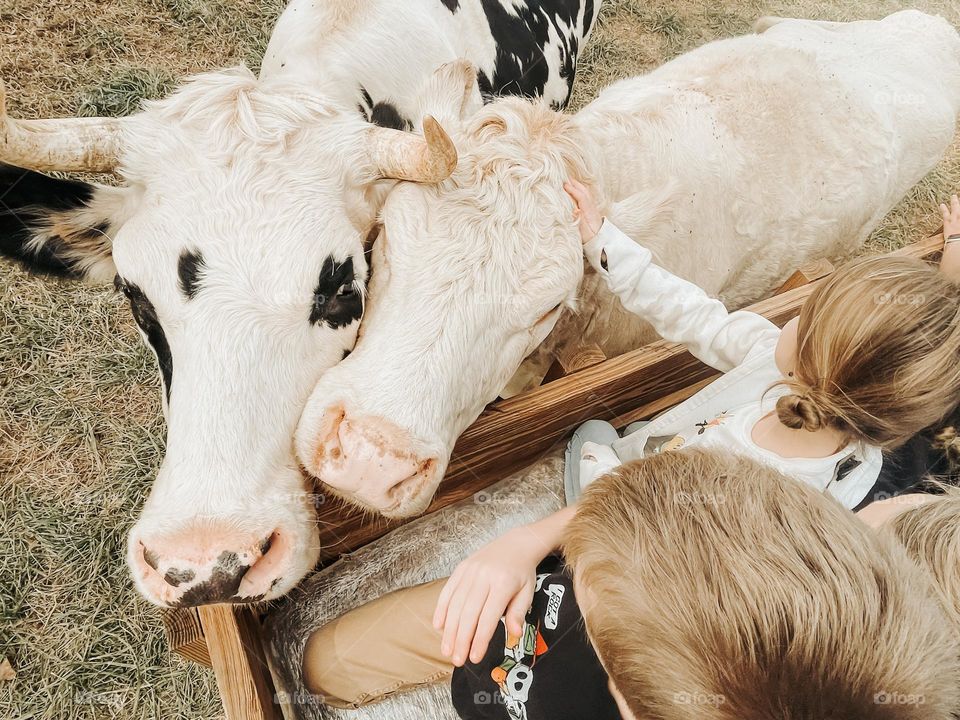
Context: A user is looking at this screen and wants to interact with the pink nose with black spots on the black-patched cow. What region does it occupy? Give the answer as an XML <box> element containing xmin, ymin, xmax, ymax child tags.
<box><xmin>132</xmin><ymin>525</ymin><xmax>291</xmax><ymax>607</ymax></box>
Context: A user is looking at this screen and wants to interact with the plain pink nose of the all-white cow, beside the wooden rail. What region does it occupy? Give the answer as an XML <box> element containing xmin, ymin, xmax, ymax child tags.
<box><xmin>308</xmin><ymin>407</ymin><xmax>440</xmax><ymax>517</ymax></box>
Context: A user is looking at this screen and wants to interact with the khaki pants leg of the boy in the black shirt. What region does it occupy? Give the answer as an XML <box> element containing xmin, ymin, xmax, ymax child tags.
<box><xmin>303</xmin><ymin>578</ymin><xmax>453</xmax><ymax>708</ymax></box>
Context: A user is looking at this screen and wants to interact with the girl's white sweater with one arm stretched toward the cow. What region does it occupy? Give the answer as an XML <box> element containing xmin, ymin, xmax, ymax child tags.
<box><xmin>581</xmin><ymin>220</ymin><xmax>882</xmax><ymax>508</ymax></box>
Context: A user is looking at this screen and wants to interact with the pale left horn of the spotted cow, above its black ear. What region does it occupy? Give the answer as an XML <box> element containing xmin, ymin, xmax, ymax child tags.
<box><xmin>0</xmin><ymin>81</ymin><xmax>124</xmax><ymax>172</ymax></box>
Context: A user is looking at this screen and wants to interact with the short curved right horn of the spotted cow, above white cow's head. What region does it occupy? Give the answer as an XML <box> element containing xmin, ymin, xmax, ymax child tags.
<box><xmin>368</xmin><ymin>115</ymin><xmax>457</xmax><ymax>183</ymax></box>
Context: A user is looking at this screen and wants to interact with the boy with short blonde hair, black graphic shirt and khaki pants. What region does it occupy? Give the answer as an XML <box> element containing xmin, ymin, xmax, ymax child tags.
<box><xmin>304</xmin><ymin>450</ymin><xmax>960</xmax><ymax>720</ymax></box>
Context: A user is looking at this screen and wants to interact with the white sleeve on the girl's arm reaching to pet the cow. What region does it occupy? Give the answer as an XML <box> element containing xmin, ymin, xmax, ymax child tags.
<box><xmin>584</xmin><ymin>220</ymin><xmax>780</xmax><ymax>372</ymax></box>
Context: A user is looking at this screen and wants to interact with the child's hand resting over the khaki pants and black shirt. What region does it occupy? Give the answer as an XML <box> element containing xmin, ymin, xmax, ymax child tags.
<box><xmin>433</xmin><ymin>527</ymin><xmax>545</xmax><ymax>667</ymax></box>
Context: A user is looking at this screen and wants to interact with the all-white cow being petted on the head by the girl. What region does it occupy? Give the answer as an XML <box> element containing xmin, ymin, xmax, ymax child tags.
<box><xmin>297</xmin><ymin>11</ymin><xmax>960</xmax><ymax>517</ymax></box>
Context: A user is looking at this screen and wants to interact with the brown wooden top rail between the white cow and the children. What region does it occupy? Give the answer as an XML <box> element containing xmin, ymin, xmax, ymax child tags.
<box><xmin>318</xmin><ymin>237</ymin><xmax>943</xmax><ymax>561</ymax></box>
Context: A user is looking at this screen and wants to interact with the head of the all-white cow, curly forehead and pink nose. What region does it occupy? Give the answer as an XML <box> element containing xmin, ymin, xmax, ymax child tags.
<box><xmin>296</xmin><ymin>59</ymin><xmax>589</xmax><ymax>517</ymax></box>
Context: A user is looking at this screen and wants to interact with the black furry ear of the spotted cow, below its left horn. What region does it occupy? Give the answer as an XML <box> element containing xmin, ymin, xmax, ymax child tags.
<box><xmin>0</xmin><ymin>164</ymin><xmax>137</xmax><ymax>282</ymax></box>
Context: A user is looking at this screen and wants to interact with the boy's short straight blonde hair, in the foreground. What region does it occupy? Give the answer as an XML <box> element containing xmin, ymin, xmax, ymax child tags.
<box><xmin>564</xmin><ymin>450</ymin><xmax>960</xmax><ymax>720</ymax></box>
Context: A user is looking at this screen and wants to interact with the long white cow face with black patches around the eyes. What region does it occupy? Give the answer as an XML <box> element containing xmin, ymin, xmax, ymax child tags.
<box><xmin>113</xmin><ymin>73</ymin><xmax>373</xmax><ymax>604</ymax></box>
